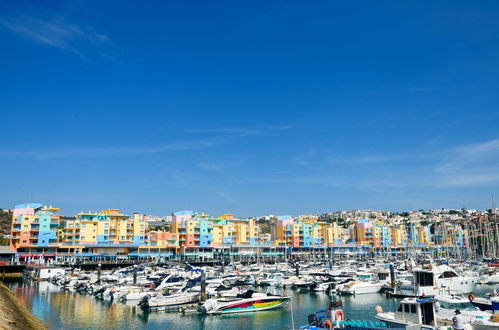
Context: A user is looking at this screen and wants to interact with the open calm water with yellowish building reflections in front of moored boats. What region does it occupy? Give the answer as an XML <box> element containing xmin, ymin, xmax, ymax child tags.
<box><xmin>7</xmin><ymin>281</ymin><xmax>493</xmax><ymax>329</ymax></box>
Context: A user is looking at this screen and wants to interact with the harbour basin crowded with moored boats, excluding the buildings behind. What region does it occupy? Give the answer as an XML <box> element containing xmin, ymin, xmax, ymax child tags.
<box><xmin>2</xmin><ymin>259</ymin><xmax>499</xmax><ymax>329</ymax></box>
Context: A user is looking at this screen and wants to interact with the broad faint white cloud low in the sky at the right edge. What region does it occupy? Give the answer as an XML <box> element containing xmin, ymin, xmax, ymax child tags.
<box><xmin>288</xmin><ymin>139</ymin><xmax>499</xmax><ymax>191</ymax></box>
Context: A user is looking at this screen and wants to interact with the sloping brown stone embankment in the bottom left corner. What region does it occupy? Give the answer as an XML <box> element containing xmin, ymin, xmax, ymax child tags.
<box><xmin>0</xmin><ymin>282</ymin><xmax>45</xmax><ymax>330</ymax></box>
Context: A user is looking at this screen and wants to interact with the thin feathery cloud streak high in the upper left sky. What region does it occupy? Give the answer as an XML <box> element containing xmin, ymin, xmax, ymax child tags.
<box><xmin>0</xmin><ymin>15</ymin><xmax>110</xmax><ymax>59</ymax></box>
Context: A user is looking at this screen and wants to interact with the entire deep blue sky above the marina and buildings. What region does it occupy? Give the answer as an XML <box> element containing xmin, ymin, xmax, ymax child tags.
<box><xmin>0</xmin><ymin>1</ymin><xmax>499</xmax><ymax>216</ymax></box>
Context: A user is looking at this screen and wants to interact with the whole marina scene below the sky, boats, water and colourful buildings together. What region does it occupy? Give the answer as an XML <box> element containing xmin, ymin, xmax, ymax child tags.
<box><xmin>0</xmin><ymin>203</ymin><xmax>499</xmax><ymax>330</ymax></box>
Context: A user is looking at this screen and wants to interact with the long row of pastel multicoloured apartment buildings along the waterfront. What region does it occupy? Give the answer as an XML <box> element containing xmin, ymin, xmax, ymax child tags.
<box><xmin>6</xmin><ymin>203</ymin><xmax>476</xmax><ymax>257</ymax></box>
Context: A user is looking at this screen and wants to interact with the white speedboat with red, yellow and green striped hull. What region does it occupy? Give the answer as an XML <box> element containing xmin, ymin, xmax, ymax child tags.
<box><xmin>198</xmin><ymin>290</ymin><xmax>289</xmax><ymax>314</ymax></box>
